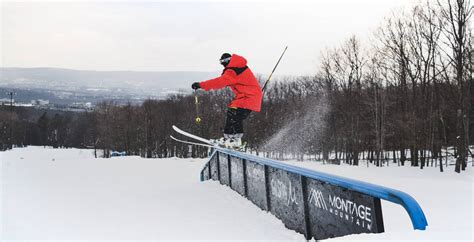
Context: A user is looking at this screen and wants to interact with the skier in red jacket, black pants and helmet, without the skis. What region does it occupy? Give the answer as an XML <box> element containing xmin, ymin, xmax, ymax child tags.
<box><xmin>191</xmin><ymin>53</ymin><xmax>263</xmax><ymax>148</ymax></box>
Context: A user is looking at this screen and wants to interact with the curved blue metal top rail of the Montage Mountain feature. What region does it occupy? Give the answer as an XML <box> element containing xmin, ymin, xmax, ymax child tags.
<box><xmin>201</xmin><ymin>148</ymin><xmax>428</xmax><ymax>230</ymax></box>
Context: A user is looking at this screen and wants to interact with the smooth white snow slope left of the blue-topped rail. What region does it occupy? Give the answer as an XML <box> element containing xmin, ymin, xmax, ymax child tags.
<box><xmin>0</xmin><ymin>147</ymin><xmax>303</xmax><ymax>241</ymax></box>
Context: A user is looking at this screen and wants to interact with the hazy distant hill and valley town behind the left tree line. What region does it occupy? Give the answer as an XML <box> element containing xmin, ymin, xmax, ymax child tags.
<box><xmin>0</xmin><ymin>68</ymin><xmax>218</xmax><ymax>104</ymax></box>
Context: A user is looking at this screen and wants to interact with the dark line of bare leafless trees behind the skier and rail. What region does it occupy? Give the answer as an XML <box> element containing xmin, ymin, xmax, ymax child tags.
<box><xmin>0</xmin><ymin>0</ymin><xmax>474</xmax><ymax>172</ymax></box>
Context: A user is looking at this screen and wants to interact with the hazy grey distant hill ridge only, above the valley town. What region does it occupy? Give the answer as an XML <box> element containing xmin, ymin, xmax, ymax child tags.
<box><xmin>0</xmin><ymin>68</ymin><xmax>218</xmax><ymax>95</ymax></box>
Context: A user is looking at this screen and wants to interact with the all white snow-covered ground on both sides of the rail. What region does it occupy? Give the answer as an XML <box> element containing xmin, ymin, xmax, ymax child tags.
<box><xmin>0</xmin><ymin>147</ymin><xmax>474</xmax><ymax>241</ymax></box>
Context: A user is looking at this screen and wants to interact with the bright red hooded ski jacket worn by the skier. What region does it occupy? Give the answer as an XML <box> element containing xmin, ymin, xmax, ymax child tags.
<box><xmin>199</xmin><ymin>54</ymin><xmax>262</xmax><ymax>112</ymax></box>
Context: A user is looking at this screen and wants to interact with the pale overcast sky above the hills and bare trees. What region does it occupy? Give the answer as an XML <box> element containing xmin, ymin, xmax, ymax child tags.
<box><xmin>0</xmin><ymin>0</ymin><xmax>415</xmax><ymax>75</ymax></box>
